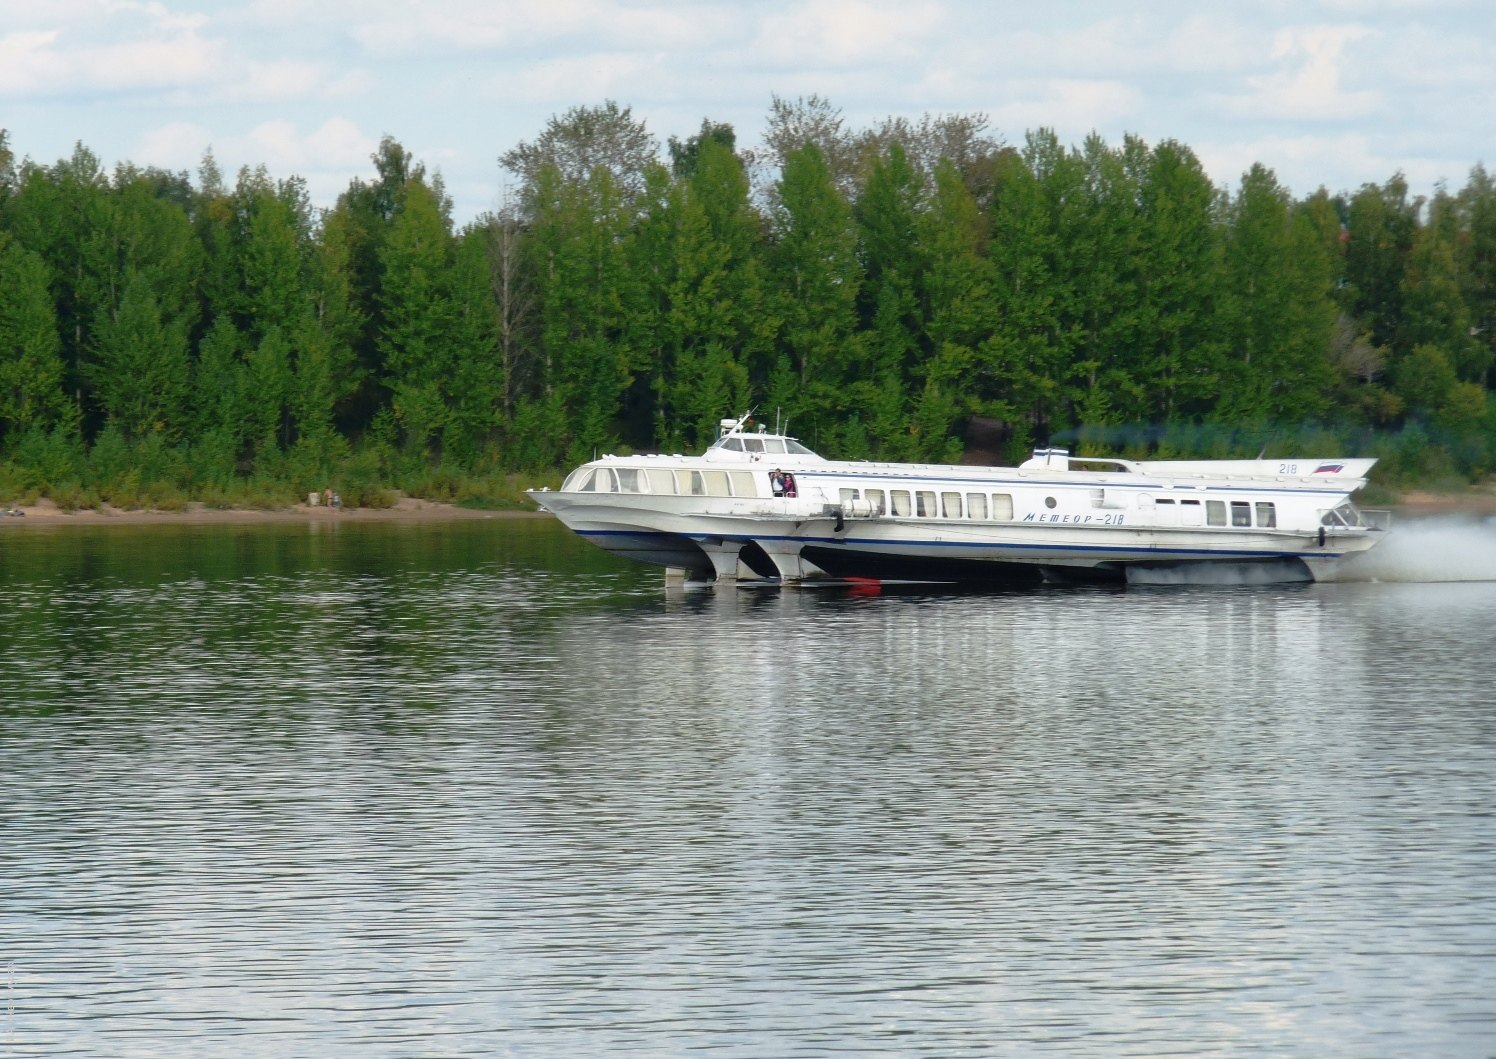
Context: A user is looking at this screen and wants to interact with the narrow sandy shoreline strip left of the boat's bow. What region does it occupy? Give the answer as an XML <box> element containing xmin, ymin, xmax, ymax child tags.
<box><xmin>0</xmin><ymin>497</ymin><xmax>549</xmax><ymax>530</ymax></box>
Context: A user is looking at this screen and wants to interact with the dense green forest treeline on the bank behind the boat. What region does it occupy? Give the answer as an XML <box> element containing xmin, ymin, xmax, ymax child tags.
<box><xmin>0</xmin><ymin>97</ymin><xmax>1496</xmax><ymax>504</ymax></box>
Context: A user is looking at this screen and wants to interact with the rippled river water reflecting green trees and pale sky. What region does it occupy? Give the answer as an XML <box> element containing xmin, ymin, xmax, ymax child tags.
<box><xmin>0</xmin><ymin>519</ymin><xmax>1496</xmax><ymax>1059</ymax></box>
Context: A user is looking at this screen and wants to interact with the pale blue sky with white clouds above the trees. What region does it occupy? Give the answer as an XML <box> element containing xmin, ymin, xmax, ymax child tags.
<box><xmin>0</xmin><ymin>0</ymin><xmax>1496</xmax><ymax>224</ymax></box>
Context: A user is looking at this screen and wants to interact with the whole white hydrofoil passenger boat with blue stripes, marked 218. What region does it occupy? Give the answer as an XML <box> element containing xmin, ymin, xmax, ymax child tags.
<box><xmin>530</xmin><ymin>416</ymin><xmax>1388</xmax><ymax>582</ymax></box>
